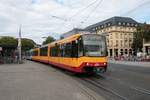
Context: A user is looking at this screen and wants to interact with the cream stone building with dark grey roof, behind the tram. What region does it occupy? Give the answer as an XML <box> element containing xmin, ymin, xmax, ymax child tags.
<box><xmin>85</xmin><ymin>17</ymin><xmax>139</xmax><ymax>57</ymax></box>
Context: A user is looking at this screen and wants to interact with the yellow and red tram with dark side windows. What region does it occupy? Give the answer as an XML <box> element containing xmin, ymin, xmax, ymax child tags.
<box><xmin>27</xmin><ymin>34</ymin><xmax>107</xmax><ymax>73</ymax></box>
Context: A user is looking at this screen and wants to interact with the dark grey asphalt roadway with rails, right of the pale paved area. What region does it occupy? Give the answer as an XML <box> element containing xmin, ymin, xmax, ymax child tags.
<box><xmin>73</xmin><ymin>62</ymin><xmax>150</xmax><ymax>100</ymax></box>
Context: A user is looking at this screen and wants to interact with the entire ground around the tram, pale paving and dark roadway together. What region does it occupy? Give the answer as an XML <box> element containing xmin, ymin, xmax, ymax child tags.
<box><xmin>0</xmin><ymin>61</ymin><xmax>150</xmax><ymax>100</ymax></box>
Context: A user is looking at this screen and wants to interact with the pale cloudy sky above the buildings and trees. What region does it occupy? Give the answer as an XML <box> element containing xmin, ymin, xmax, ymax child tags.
<box><xmin>0</xmin><ymin>0</ymin><xmax>150</xmax><ymax>44</ymax></box>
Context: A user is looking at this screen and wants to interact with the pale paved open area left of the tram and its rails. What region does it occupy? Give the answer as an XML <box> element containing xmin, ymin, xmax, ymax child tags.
<box><xmin>0</xmin><ymin>61</ymin><xmax>104</xmax><ymax>100</ymax></box>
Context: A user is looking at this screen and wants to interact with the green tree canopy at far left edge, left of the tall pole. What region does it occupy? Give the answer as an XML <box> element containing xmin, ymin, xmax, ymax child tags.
<box><xmin>0</xmin><ymin>36</ymin><xmax>18</xmax><ymax>47</ymax></box>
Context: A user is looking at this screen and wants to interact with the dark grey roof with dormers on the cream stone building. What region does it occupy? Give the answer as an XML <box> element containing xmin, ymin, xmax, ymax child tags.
<box><xmin>85</xmin><ymin>16</ymin><xmax>139</xmax><ymax>31</ymax></box>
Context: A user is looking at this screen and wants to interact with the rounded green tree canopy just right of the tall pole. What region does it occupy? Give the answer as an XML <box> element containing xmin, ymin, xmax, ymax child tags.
<box><xmin>21</xmin><ymin>38</ymin><xmax>35</xmax><ymax>51</ymax></box>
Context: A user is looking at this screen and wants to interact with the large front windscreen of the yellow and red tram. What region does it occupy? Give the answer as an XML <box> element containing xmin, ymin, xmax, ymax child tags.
<box><xmin>83</xmin><ymin>34</ymin><xmax>107</xmax><ymax>57</ymax></box>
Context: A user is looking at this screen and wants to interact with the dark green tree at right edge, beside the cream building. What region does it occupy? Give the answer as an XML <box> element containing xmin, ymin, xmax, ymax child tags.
<box><xmin>132</xmin><ymin>23</ymin><xmax>150</xmax><ymax>53</ymax></box>
